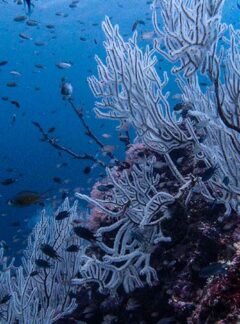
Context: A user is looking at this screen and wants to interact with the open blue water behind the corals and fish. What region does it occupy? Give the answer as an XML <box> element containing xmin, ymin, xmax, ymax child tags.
<box><xmin>0</xmin><ymin>0</ymin><xmax>240</xmax><ymax>254</ymax></box>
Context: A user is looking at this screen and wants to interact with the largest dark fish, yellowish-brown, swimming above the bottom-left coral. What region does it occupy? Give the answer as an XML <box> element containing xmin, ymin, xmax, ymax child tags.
<box><xmin>8</xmin><ymin>191</ymin><xmax>43</xmax><ymax>207</ymax></box>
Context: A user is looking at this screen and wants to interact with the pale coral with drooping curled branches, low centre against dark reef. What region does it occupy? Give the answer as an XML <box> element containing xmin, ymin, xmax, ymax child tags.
<box><xmin>73</xmin><ymin>157</ymin><xmax>175</xmax><ymax>292</ymax></box>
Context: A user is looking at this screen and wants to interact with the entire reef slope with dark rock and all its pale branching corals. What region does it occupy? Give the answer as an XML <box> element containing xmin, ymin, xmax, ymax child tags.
<box><xmin>0</xmin><ymin>0</ymin><xmax>240</xmax><ymax>324</ymax></box>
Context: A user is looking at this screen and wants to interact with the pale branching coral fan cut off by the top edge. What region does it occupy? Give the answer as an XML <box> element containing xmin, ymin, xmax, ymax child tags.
<box><xmin>152</xmin><ymin>0</ymin><xmax>226</xmax><ymax>77</ymax></box>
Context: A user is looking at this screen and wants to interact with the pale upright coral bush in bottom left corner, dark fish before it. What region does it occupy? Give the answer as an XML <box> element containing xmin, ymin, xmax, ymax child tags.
<box><xmin>0</xmin><ymin>199</ymin><xmax>82</xmax><ymax>324</ymax></box>
